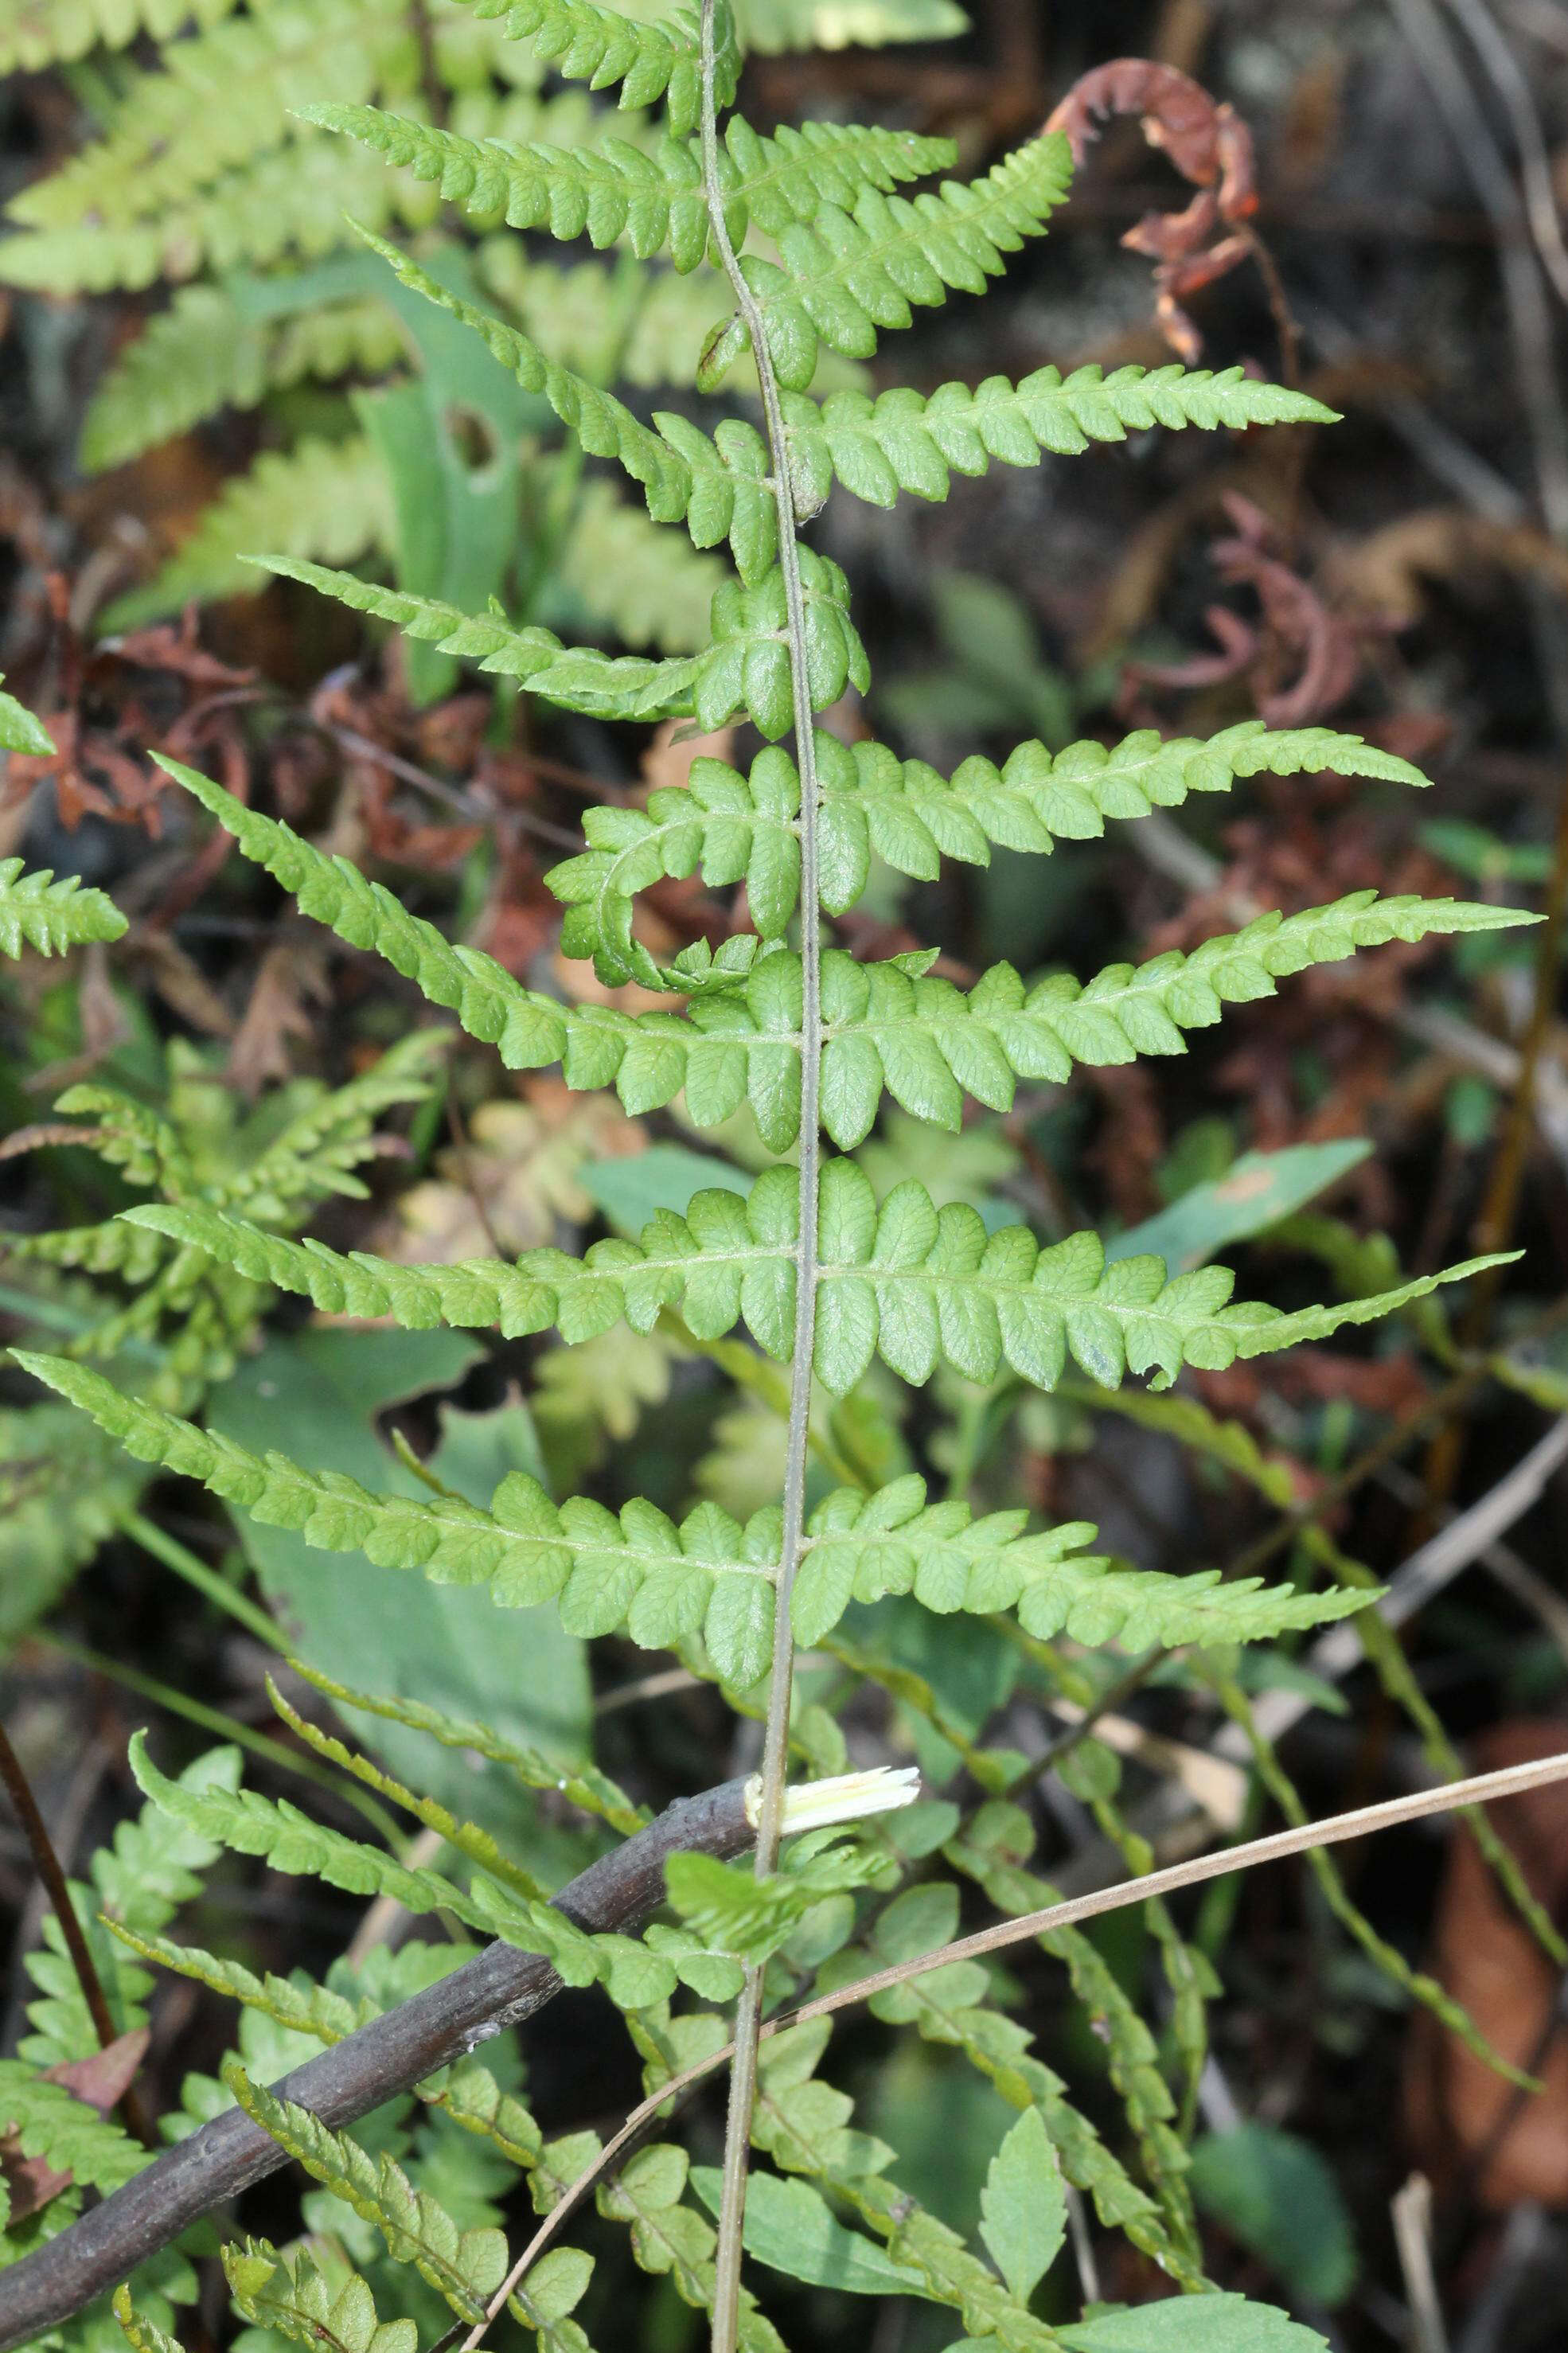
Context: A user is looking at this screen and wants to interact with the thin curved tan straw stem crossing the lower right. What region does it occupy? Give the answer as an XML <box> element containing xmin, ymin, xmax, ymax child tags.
<box><xmin>462</xmin><ymin>1750</ymin><xmax>1568</xmax><ymax>2353</ymax></box>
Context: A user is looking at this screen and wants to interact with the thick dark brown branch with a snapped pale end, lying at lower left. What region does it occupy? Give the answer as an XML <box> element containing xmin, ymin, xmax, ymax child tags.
<box><xmin>0</xmin><ymin>1781</ymin><xmax>754</xmax><ymax>2353</ymax></box>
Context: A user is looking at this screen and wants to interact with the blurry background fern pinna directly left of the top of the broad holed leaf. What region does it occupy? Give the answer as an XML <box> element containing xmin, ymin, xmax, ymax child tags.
<box><xmin>82</xmin><ymin>283</ymin><xmax>405</xmax><ymax>473</ymax></box>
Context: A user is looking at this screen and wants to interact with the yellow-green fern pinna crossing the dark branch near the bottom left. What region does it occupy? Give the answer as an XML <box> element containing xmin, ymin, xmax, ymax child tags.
<box><xmin>224</xmin><ymin>2059</ymin><xmax>506</xmax><ymax>2323</ymax></box>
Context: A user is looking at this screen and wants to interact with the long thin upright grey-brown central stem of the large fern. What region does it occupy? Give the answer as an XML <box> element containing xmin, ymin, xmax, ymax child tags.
<box><xmin>701</xmin><ymin>18</ymin><xmax>821</xmax><ymax>2353</ymax></box>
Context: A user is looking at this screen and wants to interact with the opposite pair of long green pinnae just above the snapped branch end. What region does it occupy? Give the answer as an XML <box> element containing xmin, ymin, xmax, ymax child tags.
<box><xmin>19</xmin><ymin>1356</ymin><xmax>1361</xmax><ymax>1684</ymax></box>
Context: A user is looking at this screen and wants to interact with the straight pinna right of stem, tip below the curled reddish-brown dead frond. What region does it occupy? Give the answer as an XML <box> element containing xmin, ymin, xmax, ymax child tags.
<box><xmin>784</xmin><ymin>365</ymin><xmax>1337</xmax><ymax>513</ymax></box>
